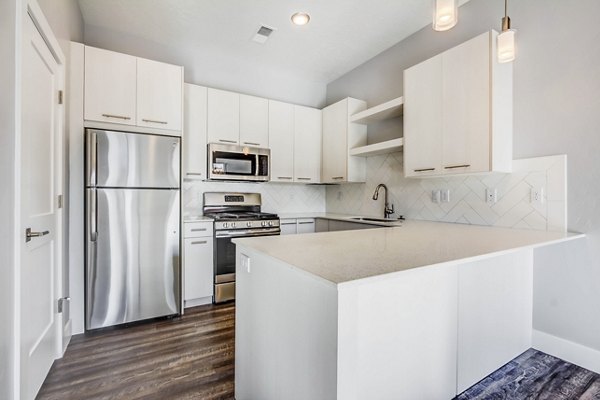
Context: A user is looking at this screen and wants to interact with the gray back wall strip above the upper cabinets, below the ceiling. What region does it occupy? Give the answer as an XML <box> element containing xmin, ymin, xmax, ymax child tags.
<box><xmin>82</xmin><ymin>24</ymin><xmax>325</xmax><ymax>107</ymax></box>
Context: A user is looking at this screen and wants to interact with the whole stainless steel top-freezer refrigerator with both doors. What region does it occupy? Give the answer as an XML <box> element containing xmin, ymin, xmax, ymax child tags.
<box><xmin>85</xmin><ymin>129</ymin><xmax>181</xmax><ymax>329</ymax></box>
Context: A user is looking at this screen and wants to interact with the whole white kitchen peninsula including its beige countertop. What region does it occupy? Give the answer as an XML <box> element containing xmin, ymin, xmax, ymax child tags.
<box><xmin>235</xmin><ymin>220</ymin><xmax>583</xmax><ymax>400</ymax></box>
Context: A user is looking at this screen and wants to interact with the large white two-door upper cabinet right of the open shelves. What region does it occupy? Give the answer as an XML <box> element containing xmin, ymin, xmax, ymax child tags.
<box><xmin>404</xmin><ymin>31</ymin><xmax>512</xmax><ymax>177</ymax></box>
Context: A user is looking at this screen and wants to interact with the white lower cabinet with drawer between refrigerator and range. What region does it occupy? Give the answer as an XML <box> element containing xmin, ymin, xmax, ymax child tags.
<box><xmin>183</xmin><ymin>222</ymin><xmax>213</xmax><ymax>308</ymax></box>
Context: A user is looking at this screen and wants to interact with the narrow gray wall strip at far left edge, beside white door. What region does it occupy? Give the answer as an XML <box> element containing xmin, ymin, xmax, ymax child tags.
<box><xmin>0</xmin><ymin>0</ymin><xmax>17</xmax><ymax>399</ymax></box>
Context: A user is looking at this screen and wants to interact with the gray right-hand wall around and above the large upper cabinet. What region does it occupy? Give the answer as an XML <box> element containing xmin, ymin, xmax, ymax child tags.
<box><xmin>327</xmin><ymin>0</ymin><xmax>600</xmax><ymax>350</ymax></box>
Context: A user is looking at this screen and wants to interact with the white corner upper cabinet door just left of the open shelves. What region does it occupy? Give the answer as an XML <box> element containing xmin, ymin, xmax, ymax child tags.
<box><xmin>322</xmin><ymin>99</ymin><xmax>348</xmax><ymax>183</ymax></box>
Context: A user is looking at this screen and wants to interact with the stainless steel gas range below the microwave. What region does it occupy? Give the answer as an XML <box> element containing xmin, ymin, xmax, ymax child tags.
<box><xmin>203</xmin><ymin>192</ymin><xmax>280</xmax><ymax>303</ymax></box>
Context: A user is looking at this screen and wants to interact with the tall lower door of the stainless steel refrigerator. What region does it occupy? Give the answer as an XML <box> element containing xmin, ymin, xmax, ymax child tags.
<box><xmin>86</xmin><ymin>189</ymin><xmax>181</xmax><ymax>329</ymax></box>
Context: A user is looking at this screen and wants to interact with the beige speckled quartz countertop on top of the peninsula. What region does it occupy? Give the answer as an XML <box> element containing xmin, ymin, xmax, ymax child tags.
<box><xmin>233</xmin><ymin>222</ymin><xmax>584</xmax><ymax>284</ymax></box>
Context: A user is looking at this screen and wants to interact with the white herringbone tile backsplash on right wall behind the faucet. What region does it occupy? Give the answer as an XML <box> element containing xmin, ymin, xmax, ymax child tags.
<box><xmin>327</xmin><ymin>153</ymin><xmax>567</xmax><ymax>231</ymax></box>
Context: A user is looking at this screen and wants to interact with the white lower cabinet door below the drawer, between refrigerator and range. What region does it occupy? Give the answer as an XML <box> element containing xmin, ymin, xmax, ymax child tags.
<box><xmin>184</xmin><ymin>236</ymin><xmax>213</xmax><ymax>300</ymax></box>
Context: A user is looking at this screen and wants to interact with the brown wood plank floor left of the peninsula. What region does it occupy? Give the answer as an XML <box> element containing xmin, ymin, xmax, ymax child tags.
<box><xmin>37</xmin><ymin>303</ymin><xmax>235</xmax><ymax>400</ymax></box>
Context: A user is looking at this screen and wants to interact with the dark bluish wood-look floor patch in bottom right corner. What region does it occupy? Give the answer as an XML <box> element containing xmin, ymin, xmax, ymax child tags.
<box><xmin>456</xmin><ymin>349</ymin><xmax>600</xmax><ymax>400</ymax></box>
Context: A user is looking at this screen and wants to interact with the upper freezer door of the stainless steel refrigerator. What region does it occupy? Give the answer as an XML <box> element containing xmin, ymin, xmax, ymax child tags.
<box><xmin>86</xmin><ymin>129</ymin><xmax>180</xmax><ymax>188</ymax></box>
